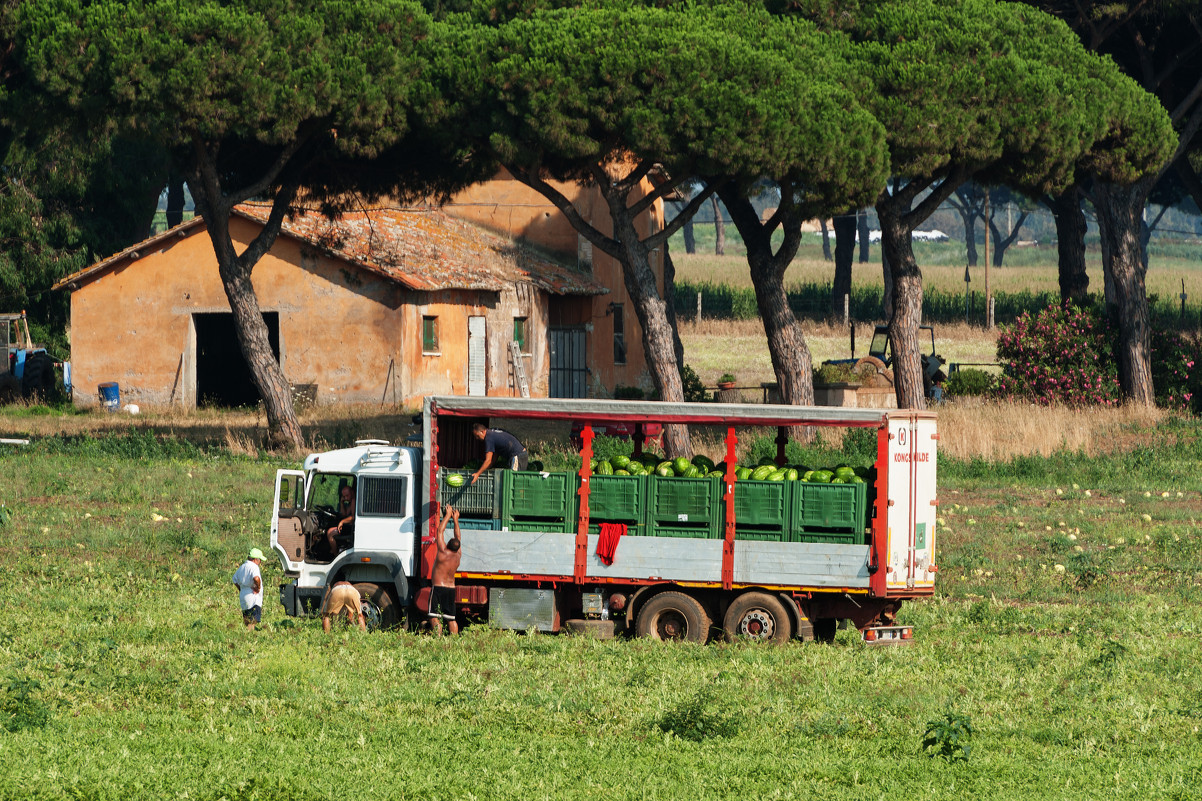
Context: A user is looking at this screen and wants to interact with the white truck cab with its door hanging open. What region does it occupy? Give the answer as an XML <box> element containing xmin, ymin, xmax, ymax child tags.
<box><xmin>272</xmin><ymin>440</ymin><xmax>422</xmax><ymax>627</ymax></box>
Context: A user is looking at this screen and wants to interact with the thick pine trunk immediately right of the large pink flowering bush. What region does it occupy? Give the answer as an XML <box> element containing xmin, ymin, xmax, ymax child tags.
<box><xmin>1094</xmin><ymin>180</ymin><xmax>1155</xmax><ymax>407</ymax></box>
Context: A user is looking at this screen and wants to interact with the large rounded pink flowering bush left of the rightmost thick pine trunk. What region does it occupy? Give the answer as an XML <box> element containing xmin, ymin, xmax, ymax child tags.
<box><xmin>996</xmin><ymin>304</ymin><xmax>1119</xmax><ymax>407</ymax></box>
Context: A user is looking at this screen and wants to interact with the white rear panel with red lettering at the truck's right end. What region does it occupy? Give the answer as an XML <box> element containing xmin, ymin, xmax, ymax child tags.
<box><xmin>886</xmin><ymin>415</ymin><xmax>936</xmax><ymax>589</ymax></box>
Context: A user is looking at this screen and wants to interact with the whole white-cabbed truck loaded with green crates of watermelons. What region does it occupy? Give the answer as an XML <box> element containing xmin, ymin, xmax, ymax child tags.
<box><xmin>272</xmin><ymin>396</ymin><xmax>939</xmax><ymax>643</ymax></box>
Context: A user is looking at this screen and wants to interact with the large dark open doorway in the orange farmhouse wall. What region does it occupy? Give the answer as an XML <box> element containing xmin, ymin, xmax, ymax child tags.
<box><xmin>192</xmin><ymin>312</ymin><xmax>280</xmax><ymax>407</ymax></box>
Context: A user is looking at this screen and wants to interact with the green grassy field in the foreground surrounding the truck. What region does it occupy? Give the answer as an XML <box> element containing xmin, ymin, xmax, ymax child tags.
<box><xmin>0</xmin><ymin>421</ymin><xmax>1202</xmax><ymax>801</ymax></box>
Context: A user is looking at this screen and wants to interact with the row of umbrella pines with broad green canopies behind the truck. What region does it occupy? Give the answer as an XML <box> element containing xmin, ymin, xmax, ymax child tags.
<box><xmin>0</xmin><ymin>0</ymin><xmax>1202</xmax><ymax>452</ymax></box>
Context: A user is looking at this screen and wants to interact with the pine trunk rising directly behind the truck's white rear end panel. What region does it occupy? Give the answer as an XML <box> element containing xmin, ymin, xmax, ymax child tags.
<box><xmin>876</xmin><ymin>202</ymin><xmax>927</xmax><ymax>409</ymax></box>
